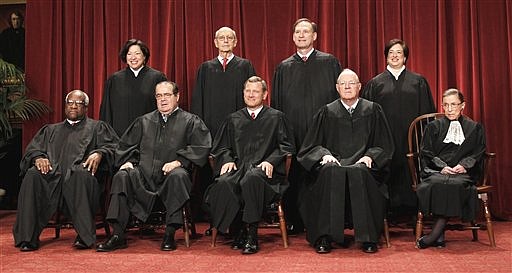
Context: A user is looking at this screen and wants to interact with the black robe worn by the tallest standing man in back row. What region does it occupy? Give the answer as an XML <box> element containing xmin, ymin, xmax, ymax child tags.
<box><xmin>271</xmin><ymin>50</ymin><xmax>341</xmax><ymax>147</ymax></box>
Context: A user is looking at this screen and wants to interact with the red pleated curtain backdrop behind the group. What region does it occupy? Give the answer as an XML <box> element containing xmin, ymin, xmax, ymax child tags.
<box><xmin>24</xmin><ymin>0</ymin><xmax>512</xmax><ymax>219</ymax></box>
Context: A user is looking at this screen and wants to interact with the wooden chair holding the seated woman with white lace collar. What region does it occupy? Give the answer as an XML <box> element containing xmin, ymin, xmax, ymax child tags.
<box><xmin>407</xmin><ymin>113</ymin><xmax>496</xmax><ymax>247</ymax></box>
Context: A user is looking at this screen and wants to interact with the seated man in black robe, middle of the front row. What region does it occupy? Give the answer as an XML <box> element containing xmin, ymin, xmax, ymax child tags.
<box><xmin>205</xmin><ymin>76</ymin><xmax>295</xmax><ymax>254</ymax></box>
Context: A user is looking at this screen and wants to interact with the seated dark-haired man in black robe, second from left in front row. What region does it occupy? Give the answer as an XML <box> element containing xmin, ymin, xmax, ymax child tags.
<box><xmin>96</xmin><ymin>81</ymin><xmax>211</xmax><ymax>251</ymax></box>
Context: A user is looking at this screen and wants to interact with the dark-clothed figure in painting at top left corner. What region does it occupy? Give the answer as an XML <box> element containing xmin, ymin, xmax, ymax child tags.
<box><xmin>0</xmin><ymin>11</ymin><xmax>25</xmax><ymax>71</ymax></box>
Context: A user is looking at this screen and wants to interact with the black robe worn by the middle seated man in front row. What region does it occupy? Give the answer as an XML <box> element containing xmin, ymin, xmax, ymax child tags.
<box><xmin>205</xmin><ymin>106</ymin><xmax>295</xmax><ymax>232</ymax></box>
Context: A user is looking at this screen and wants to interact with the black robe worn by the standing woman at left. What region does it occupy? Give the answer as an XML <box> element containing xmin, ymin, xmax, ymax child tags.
<box><xmin>100</xmin><ymin>66</ymin><xmax>167</xmax><ymax>136</ymax></box>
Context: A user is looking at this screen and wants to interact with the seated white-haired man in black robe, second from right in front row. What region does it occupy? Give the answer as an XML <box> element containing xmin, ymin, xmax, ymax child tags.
<box><xmin>297</xmin><ymin>69</ymin><xmax>394</xmax><ymax>253</ymax></box>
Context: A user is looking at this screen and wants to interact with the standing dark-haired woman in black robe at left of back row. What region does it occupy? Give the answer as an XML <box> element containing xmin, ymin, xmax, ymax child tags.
<box><xmin>100</xmin><ymin>39</ymin><xmax>167</xmax><ymax>136</ymax></box>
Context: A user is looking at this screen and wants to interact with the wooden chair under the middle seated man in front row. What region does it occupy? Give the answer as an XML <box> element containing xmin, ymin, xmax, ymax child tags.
<box><xmin>209</xmin><ymin>154</ymin><xmax>292</xmax><ymax>248</ymax></box>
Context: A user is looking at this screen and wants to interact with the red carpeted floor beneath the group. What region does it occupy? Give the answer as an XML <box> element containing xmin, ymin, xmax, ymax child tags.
<box><xmin>0</xmin><ymin>211</ymin><xmax>512</xmax><ymax>273</ymax></box>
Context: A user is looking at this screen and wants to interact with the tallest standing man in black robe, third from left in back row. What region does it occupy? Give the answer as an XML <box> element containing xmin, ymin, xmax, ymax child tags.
<box><xmin>271</xmin><ymin>18</ymin><xmax>341</xmax><ymax>234</ymax></box>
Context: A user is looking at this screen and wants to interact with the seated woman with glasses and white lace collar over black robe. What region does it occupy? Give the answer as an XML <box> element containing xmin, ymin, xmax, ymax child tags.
<box><xmin>416</xmin><ymin>89</ymin><xmax>485</xmax><ymax>249</ymax></box>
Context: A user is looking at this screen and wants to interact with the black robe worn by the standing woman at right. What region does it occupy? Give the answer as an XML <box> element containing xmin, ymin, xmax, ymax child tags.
<box><xmin>361</xmin><ymin>69</ymin><xmax>436</xmax><ymax>207</ymax></box>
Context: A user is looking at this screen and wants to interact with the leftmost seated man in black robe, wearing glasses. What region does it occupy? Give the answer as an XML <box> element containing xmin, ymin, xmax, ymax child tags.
<box><xmin>13</xmin><ymin>90</ymin><xmax>118</xmax><ymax>251</ymax></box>
